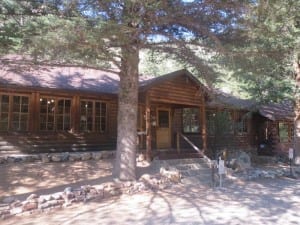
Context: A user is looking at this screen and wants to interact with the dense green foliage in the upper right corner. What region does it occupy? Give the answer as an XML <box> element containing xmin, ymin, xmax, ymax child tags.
<box><xmin>217</xmin><ymin>0</ymin><xmax>300</xmax><ymax>102</ymax></box>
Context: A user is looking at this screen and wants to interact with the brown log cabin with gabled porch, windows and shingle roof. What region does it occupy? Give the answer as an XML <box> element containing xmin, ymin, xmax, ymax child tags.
<box><xmin>0</xmin><ymin>56</ymin><xmax>292</xmax><ymax>158</ymax></box>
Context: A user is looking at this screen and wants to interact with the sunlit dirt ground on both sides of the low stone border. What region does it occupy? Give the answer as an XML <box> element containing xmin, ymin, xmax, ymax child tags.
<box><xmin>0</xmin><ymin>160</ymin><xmax>300</xmax><ymax>225</ymax></box>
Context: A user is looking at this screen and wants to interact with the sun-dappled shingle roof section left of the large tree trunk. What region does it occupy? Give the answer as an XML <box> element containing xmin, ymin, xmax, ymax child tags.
<box><xmin>0</xmin><ymin>57</ymin><xmax>119</xmax><ymax>94</ymax></box>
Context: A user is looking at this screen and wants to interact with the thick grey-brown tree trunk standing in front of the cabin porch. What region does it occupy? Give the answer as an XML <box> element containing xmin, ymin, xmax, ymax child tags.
<box><xmin>113</xmin><ymin>45</ymin><xmax>139</xmax><ymax>180</ymax></box>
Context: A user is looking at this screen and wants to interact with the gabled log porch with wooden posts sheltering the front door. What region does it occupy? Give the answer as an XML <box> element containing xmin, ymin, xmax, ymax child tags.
<box><xmin>138</xmin><ymin>71</ymin><xmax>207</xmax><ymax>159</ymax></box>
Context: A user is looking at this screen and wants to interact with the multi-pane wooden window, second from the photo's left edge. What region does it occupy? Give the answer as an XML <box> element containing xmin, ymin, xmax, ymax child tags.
<box><xmin>12</xmin><ymin>96</ymin><xmax>29</xmax><ymax>131</ymax></box>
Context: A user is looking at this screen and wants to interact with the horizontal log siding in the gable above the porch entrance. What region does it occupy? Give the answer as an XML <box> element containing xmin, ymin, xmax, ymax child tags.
<box><xmin>148</xmin><ymin>77</ymin><xmax>202</xmax><ymax>106</ymax></box>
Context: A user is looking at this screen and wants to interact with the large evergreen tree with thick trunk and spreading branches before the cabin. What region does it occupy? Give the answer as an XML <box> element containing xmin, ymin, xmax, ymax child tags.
<box><xmin>0</xmin><ymin>0</ymin><xmax>251</xmax><ymax>180</ymax></box>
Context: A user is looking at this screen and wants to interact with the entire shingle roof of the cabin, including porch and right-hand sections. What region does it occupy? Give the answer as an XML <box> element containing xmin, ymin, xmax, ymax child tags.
<box><xmin>0</xmin><ymin>56</ymin><xmax>295</xmax><ymax>120</ymax></box>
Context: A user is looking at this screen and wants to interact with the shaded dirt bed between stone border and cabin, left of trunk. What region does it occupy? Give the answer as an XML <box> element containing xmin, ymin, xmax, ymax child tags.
<box><xmin>0</xmin><ymin>160</ymin><xmax>112</xmax><ymax>200</ymax></box>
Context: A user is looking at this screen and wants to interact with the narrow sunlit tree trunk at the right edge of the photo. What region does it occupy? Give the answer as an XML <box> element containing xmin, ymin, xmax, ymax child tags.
<box><xmin>294</xmin><ymin>58</ymin><xmax>300</xmax><ymax>165</ymax></box>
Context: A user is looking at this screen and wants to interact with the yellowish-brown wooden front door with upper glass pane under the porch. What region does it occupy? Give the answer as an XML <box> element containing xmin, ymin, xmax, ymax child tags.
<box><xmin>156</xmin><ymin>109</ymin><xmax>171</xmax><ymax>149</ymax></box>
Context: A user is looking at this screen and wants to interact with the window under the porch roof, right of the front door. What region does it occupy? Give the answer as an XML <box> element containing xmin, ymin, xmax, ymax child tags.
<box><xmin>182</xmin><ymin>108</ymin><xmax>200</xmax><ymax>133</ymax></box>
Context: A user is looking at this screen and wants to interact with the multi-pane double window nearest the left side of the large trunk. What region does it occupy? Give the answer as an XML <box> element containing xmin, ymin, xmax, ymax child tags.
<box><xmin>80</xmin><ymin>100</ymin><xmax>107</xmax><ymax>133</ymax></box>
